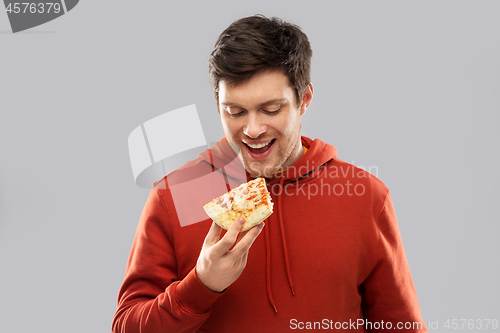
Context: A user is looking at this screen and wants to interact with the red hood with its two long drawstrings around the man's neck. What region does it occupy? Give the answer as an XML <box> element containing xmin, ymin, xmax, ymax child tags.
<box><xmin>198</xmin><ymin>136</ymin><xmax>337</xmax><ymax>312</ymax></box>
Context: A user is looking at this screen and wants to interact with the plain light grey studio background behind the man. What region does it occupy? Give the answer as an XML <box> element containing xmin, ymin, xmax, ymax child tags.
<box><xmin>0</xmin><ymin>0</ymin><xmax>500</xmax><ymax>333</ymax></box>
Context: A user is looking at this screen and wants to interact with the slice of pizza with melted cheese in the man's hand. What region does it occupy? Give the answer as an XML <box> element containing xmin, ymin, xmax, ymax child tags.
<box><xmin>203</xmin><ymin>178</ymin><xmax>273</xmax><ymax>231</ymax></box>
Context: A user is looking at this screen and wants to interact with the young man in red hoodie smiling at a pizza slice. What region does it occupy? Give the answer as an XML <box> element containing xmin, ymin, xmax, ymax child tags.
<box><xmin>113</xmin><ymin>15</ymin><xmax>427</xmax><ymax>333</ymax></box>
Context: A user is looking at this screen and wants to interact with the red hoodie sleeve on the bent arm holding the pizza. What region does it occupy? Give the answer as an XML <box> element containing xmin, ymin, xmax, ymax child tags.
<box><xmin>112</xmin><ymin>188</ymin><xmax>223</xmax><ymax>333</ymax></box>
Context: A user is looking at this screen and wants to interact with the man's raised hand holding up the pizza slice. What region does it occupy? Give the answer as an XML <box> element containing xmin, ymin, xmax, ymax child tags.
<box><xmin>196</xmin><ymin>217</ymin><xmax>264</xmax><ymax>292</ymax></box>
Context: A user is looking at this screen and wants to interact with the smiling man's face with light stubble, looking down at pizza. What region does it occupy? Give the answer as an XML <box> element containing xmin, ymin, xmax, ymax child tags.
<box><xmin>219</xmin><ymin>71</ymin><xmax>313</xmax><ymax>178</ymax></box>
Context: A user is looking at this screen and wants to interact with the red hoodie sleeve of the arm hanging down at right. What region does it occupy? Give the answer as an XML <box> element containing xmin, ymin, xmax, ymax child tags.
<box><xmin>361</xmin><ymin>192</ymin><xmax>427</xmax><ymax>333</ymax></box>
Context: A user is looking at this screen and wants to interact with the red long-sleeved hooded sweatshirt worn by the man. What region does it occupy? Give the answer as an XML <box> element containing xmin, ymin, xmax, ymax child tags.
<box><xmin>113</xmin><ymin>137</ymin><xmax>427</xmax><ymax>333</ymax></box>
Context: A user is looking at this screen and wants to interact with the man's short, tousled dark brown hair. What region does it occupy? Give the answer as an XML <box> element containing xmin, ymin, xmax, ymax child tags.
<box><xmin>208</xmin><ymin>15</ymin><xmax>312</xmax><ymax>108</ymax></box>
